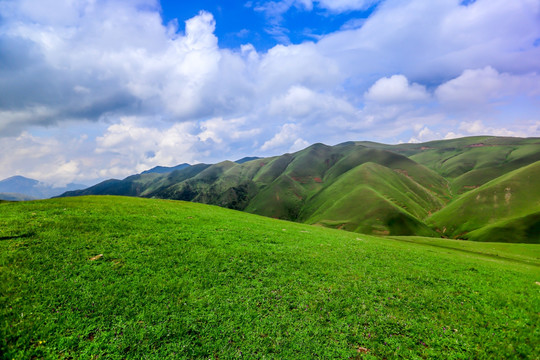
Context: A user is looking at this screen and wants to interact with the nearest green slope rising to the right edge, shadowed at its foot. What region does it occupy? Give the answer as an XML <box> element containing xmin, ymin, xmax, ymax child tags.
<box><xmin>428</xmin><ymin>161</ymin><xmax>540</xmax><ymax>242</ymax></box>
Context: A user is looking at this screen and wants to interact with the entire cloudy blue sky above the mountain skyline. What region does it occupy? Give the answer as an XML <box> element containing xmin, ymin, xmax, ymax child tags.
<box><xmin>0</xmin><ymin>0</ymin><xmax>540</xmax><ymax>186</ymax></box>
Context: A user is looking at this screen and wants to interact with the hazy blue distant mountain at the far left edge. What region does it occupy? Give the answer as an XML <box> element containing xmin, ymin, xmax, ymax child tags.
<box><xmin>0</xmin><ymin>176</ymin><xmax>86</xmax><ymax>200</ymax></box>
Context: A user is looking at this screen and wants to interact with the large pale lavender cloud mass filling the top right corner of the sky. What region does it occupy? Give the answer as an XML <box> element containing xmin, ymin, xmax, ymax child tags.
<box><xmin>318</xmin><ymin>0</ymin><xmax>540</xmax><ymax>87</ymax></box>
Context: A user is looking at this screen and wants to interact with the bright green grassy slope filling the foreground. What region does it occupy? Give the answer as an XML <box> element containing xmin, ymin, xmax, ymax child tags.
<box><xmin>0</xmin><ymin>197</ymin><xmax>540</xmax><ymax>359</ymax></box>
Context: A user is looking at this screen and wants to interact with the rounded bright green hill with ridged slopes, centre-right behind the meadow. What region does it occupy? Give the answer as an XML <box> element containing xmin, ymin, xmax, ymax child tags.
<box><xmin>301</xmin><ymin>162</ymin><xmax>444</xmax><ymax>235</ymax></box>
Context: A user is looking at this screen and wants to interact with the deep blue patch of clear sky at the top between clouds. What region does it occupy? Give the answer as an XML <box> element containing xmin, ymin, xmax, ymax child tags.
<box><xmin>161</xmin><ymin>0</ymin><xmax>376</xmax><ymax>51</ymax></box>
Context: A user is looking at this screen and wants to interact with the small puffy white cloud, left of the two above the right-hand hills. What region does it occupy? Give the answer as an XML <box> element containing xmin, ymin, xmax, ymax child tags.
<box><xmin>364</xmin><ymin>75</ymin><xmax>429</xmax><ymax>104</ymax></box>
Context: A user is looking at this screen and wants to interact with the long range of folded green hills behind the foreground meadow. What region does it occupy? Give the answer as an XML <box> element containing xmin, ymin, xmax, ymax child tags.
<box><xmin>59</xmin><ymin>137</ymin><xmax>540</xmax><ymax>242</ymax></box>
